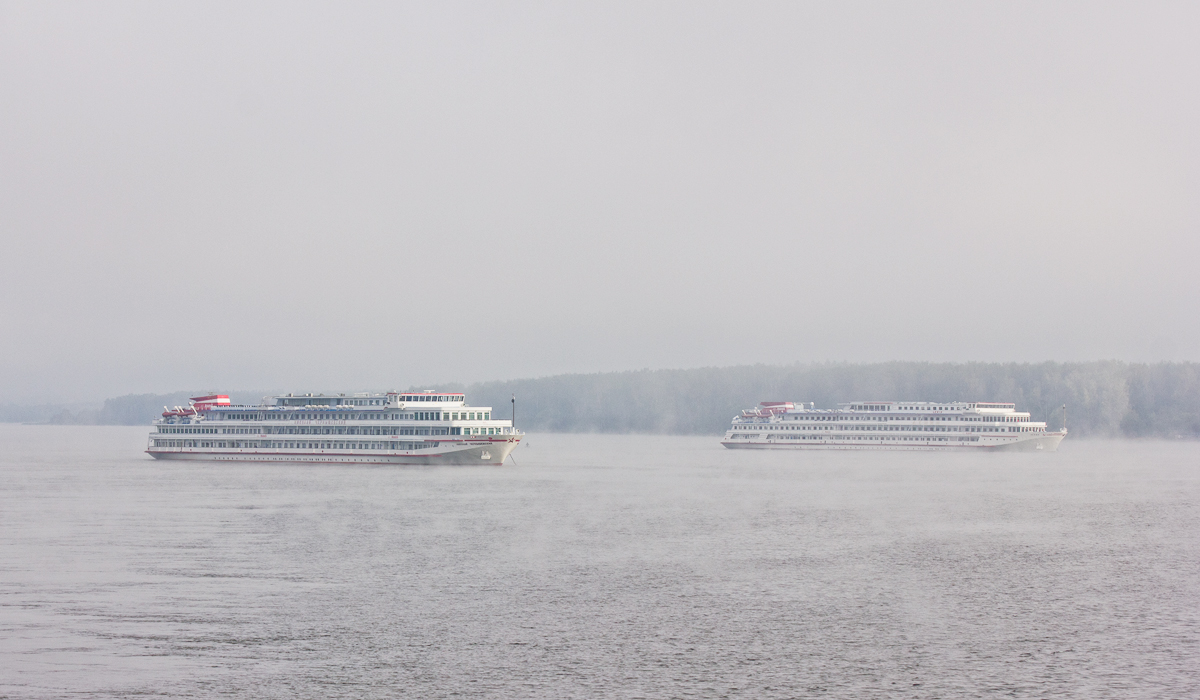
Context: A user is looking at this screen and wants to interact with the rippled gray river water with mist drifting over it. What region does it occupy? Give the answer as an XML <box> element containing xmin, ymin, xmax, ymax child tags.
<box><xmin>0</xmin><ymin>425</ymin><xmax>1200</xmax><ymax>699</ymax></box>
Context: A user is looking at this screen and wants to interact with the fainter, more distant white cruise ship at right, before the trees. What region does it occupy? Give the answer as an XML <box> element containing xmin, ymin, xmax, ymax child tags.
<box><xmin>721</xmin><ymin>401</ymin><xmax>1067</xmax><ymax>451</ymax></box>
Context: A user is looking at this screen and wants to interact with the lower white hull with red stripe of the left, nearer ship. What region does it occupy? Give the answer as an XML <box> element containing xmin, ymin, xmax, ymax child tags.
<box><xmin>146</xmin><ymin>437</ymin><xmax>521</xmax><ymax>466</ymax></box>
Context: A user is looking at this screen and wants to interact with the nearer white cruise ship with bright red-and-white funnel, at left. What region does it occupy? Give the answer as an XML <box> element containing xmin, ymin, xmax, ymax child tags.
<box><xmin>146</xmin><ymin>391</ymin><xmax>524</xmax><ymax>465</ymax></box>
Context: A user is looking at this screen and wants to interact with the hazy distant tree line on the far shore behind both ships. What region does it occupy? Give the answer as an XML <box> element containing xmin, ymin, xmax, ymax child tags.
<box><xmin>11</xmin><ymin>361</ymin><xmax>1200</xmax><ymax>438</ymax></box>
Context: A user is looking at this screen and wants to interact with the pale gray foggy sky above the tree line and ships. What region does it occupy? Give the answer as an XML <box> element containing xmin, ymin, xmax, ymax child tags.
<box><xmin>0</xmin><ymin>1</ymin><xmax>1200</xmax><ymax>401</ymax></box>
